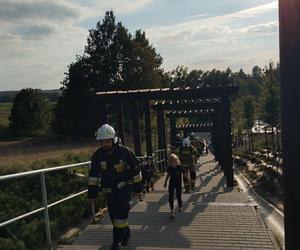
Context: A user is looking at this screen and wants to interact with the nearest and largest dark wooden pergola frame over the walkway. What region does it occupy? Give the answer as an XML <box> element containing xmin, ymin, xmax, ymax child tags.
<box><xmin>95</xmin><ymin>85</ymin><xmax>238</xmax><ymax>186</ymax></box>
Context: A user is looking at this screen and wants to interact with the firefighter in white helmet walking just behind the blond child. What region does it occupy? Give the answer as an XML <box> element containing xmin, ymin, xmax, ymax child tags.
<box><xmin>180</xmin><ymin>137</ymin><xmax>198</xmax><ymax>193</ymax></box>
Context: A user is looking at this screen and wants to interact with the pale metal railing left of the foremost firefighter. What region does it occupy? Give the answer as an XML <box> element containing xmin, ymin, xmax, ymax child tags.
<box><xmin>0</xmin><ymin>161</ymin><xmax>91</xmax><ymax>249</ymax></box>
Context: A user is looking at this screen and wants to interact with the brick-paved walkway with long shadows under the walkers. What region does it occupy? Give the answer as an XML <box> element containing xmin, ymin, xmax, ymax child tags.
<box><xmin>59</xmin><ymin>155</ymin><xmax>279</xmax><ymax>250</ymax></box>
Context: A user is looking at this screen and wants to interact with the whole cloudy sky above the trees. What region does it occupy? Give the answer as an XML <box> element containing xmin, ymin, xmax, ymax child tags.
<box><xmin>0</xmin><ymin>0</ymin><xmax>279</xmax><ymax>91</ymax></box>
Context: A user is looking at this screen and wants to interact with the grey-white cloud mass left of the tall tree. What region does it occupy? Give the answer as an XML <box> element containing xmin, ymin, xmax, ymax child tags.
<box><xmin>0</xmin><ymin>0</ymin><xmax>158</xmax><ymax>90</ymax></box>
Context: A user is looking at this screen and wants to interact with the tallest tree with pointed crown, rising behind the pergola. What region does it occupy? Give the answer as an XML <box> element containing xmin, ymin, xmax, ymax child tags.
<box><xmin>85</xmin><ymin>11</ymin><xmax>133</xmax><ymax>91</ymax></box>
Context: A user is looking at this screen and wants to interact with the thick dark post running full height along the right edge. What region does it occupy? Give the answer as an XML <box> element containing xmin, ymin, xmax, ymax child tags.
<box><xmin>279</xmin><ymin>0</ymin><xmax>300</xmax><ymax>250</ymax></box>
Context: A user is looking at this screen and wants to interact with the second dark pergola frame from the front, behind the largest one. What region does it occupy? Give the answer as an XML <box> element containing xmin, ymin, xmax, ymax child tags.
<box><xmin>153</xmin><ymin>97</ymin><xmax>227</xmax><ymax>174</ymax></box>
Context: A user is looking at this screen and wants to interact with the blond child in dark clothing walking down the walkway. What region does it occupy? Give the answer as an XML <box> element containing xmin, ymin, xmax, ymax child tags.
<box><xmin>164</xmin><ymin>154</ymin><xmax>185</xmax><ymax>218</ymax></box>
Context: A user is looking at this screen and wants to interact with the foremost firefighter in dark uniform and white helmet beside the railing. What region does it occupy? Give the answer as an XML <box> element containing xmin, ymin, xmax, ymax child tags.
<box><xmin>88</xmin><ymin>124</ymin><xmax>143</xmax><ymax>250</ymax></box>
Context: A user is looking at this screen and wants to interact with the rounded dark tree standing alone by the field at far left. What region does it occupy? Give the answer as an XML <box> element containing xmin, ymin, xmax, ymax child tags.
<box><xmin>9</xmin><ymin>88</ymin><xmax>50</xmax><ymax>134</ymax></box>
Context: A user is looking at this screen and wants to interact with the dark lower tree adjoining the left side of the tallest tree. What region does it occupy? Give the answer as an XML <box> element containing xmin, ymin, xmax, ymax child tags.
<box><xmin>52</xmin><ymin>57</ymin><xmax>97</xmax><ymax>138</ymax></box>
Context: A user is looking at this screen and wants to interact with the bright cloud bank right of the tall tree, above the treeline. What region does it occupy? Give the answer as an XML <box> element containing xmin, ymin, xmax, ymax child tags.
<box><xmin>146</xmin><ymin>1</ymin><xmax>279</xmax><ymax>70</ymax></box>
